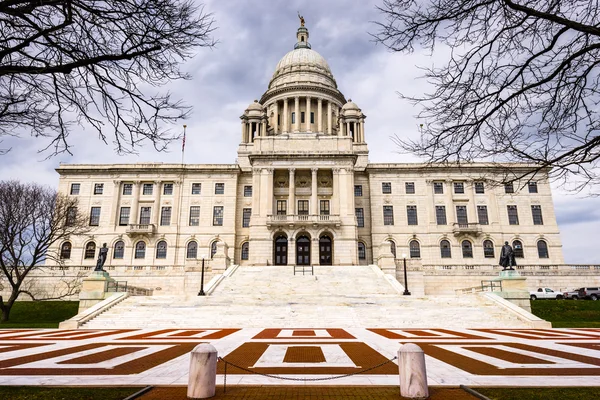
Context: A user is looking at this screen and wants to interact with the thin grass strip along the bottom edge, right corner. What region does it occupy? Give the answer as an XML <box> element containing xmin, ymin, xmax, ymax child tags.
<box><xmin>474</xmin><ymin>388</ymin><xmax>600</xmax><ymax>400</ymax></box>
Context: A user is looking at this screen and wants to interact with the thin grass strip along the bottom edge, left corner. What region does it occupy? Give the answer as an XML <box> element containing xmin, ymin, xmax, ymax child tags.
<box><xmin>0</xmin><ymin>386</ymin><xmax>142</xmax><ymax>400</ymax></box>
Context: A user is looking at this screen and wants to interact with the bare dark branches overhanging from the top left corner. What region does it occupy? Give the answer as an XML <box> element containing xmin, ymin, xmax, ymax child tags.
<box><xmin>0</xmin><ymin>0</ymin><xmax>214</xmax><ymax>154</ymax></box>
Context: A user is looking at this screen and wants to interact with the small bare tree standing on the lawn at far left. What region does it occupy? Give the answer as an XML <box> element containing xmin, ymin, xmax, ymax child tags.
<box><xmin>0</xmin><ymin>181</ymin><xmax>89</xmax><ymax>322</ymax></box>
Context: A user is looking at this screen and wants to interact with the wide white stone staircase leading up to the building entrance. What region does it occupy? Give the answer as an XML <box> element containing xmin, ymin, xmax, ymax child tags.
<box><xmin>82</xmin><ymin>266</ymin><xmax>527</xmax><ymax>329</ymax></box>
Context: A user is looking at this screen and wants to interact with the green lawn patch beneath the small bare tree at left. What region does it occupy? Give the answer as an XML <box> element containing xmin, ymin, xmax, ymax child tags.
<box><xmin>0</xmin><ymin>301</ymin><xmax>79</xmax><ymax>328</ymax></box>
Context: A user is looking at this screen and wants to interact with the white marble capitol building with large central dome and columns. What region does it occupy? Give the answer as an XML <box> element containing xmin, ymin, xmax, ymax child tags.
<box><xmin>45</xmin><ymin>22</ymin><xmax>564</xmax><ymax>294</ymax></box>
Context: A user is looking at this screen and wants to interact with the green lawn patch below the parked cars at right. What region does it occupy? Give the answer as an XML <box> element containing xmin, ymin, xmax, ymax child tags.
<box><xmin>531</xmin><ymin>300</ymin><xmax>600</xmax><ymax>328</ymax></box>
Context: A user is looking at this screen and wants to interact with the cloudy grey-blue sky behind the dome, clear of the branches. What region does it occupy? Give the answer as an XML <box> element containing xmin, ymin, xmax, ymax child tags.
<box><xmin>0</xmin><ymin>0</ymin><xmax>600</xmax><ymax>263</ymax></box>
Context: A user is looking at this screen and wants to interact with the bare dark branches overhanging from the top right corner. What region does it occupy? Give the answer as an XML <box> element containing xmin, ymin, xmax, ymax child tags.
<box><xmin>373</xmin><ymin>0</ymin><xmax>600</xmax><ymax>190</ymax></box>
